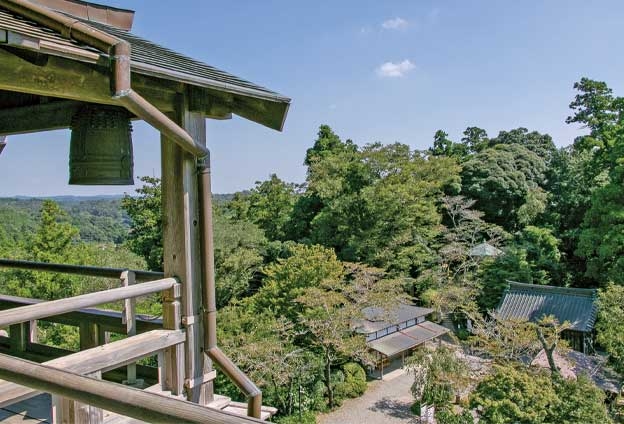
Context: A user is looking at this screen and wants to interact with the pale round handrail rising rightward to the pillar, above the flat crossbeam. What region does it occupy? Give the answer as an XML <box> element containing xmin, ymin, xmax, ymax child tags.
<box><xmin>0</xmin><ymin>278</ymin><xmax>178</xmax><ymax>327</ymax></box>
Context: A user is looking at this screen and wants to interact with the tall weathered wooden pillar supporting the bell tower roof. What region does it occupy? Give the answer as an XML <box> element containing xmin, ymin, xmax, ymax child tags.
<box><xmin>161</xmin><ymin>96</ymin><xmax>213</xmax><ymax>403</ymax></box>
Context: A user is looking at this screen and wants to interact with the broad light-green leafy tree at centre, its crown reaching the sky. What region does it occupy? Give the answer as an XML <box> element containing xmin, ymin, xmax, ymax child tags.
<box><xmin>308</xmin><ymin>144</ymin><xmax>458</xmax><ymax>272</ymax></box>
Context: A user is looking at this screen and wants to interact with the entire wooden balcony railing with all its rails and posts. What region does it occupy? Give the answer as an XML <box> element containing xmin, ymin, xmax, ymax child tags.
<box><xmin>0</xmin><ymin>260</ymin><xmax>260</xmax><ymax>423</ymax></box>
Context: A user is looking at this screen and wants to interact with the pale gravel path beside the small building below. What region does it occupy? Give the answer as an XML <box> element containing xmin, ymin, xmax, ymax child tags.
<box><xmin>316</xmin><ymin>369</ymin><xmax>419</xmax><ymax>424</ymax></box>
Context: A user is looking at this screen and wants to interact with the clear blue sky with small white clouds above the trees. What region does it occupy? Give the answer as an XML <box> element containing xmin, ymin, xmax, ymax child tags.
<box><xmin>0</xmin><ymin>0</ymin><xmax>624</xmax><ymax>196</ymax></box>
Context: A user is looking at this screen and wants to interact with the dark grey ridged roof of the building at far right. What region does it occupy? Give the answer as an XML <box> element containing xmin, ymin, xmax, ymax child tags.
<box><xmin>497</xmin><ymin>282</ymin><xmax>597</xmax><ymax>332</ymax></box>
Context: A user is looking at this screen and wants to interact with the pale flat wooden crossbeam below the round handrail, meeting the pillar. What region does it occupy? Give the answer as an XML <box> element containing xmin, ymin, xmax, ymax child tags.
<box><xmin>0</xmin><ymin>330</ymin><xmax>186</xmax><ymax>408</ymax></box>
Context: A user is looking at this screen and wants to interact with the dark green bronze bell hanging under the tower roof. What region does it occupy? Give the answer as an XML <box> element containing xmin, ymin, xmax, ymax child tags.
<box><xmin>69</xmin><ymin>105</ymin><xmax>134</xmax><ymax>185</ymax></box>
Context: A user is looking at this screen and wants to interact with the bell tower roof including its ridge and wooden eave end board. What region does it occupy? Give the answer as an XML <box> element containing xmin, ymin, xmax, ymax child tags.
<box><xmin>0</xmin><ymin>0</ymin><xmax>290</xmax><ymax>130</ymax></box>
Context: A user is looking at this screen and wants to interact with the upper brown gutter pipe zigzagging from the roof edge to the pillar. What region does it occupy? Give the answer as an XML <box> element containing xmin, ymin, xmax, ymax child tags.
<box><xmin>0</xmin><ymin>0</ymin><xmax>208</xmax><ymax>157</ymax></box>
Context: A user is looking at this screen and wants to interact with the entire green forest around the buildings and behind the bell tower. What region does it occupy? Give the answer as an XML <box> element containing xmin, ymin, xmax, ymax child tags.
<box><xmin>0</xmin><ymin>78</ymin><xmax>624</xmax><ymax>424</ymax></box>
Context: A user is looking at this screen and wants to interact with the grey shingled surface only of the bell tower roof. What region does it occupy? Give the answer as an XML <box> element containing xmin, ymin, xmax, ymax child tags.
<box><xmin>0</xmin><ymin>8</ymin><xmax>290</xmax><ymax>103</ymax></box>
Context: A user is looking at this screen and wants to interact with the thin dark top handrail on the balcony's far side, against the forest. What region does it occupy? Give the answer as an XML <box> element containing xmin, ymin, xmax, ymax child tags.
<box><xmin>0</xmin><ymin>259</ymin><xmax>165</xmax><ymax>282</ymax></box>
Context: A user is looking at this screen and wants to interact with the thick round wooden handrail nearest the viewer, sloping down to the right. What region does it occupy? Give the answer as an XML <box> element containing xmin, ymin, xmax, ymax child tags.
<box><xmin>0</xmin><ymin>355</ymin><xmax>262</xmax><ymax>424</ymax></box>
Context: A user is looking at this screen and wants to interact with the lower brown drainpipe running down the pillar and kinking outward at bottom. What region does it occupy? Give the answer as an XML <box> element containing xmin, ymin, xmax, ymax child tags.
<box><xmin>198</xmin><ymin>155</ymin><xmax>262</xmax><ymax>418</ymax></box>
